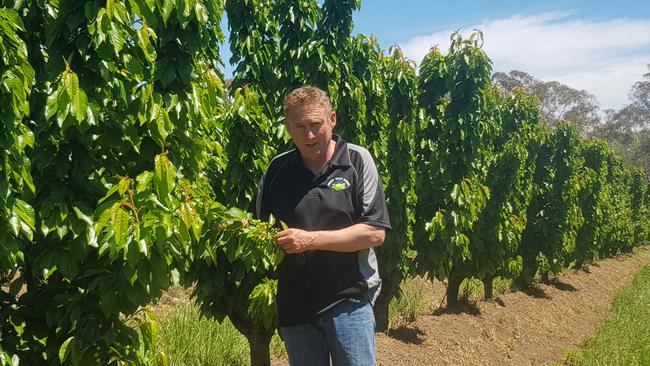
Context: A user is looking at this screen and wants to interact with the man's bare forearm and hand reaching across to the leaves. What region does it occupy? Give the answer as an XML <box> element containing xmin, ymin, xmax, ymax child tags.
<box><xmin>275</xmin><ymin>224</ymin><xmax>386</xmax><ymax>254</ymax></box>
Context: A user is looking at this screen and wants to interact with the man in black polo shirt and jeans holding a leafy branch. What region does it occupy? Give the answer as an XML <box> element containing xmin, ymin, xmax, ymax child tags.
<box><xmin>256</xmin><ymin>87</ymin><xmax>390</xmax><ymax>366</ymax></box>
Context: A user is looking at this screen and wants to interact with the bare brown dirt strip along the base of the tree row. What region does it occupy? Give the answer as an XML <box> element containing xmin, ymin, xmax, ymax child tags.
<box><xmin>273</xmin><ymin>248</ymin><xmax>650</xmax><ymax>366</ymax></box>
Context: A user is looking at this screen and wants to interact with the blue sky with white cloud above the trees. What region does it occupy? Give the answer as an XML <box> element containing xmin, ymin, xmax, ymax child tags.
<box><xmin>219</xmin><ymin>0</ymin><xmax>650</xmax><ymax>110</ymax></box>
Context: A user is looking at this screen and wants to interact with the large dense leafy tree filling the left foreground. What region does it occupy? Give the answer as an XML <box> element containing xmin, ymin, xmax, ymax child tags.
<box><xmin>0</xmin><ymin>0</ymin><xmax>228</xmax><ymax>365</ymax></box>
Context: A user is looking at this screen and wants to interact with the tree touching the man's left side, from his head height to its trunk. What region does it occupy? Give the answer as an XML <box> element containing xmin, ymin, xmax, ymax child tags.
<box><xmin>188</xmin><ymin>86</ymin><xmax>282</xmax><ymax>365</ymax></box>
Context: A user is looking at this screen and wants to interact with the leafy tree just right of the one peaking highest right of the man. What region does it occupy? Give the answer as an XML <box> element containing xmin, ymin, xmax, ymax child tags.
<box><xmin>469</xmin><ymin>88</ymin><xmax>541</xmax><ymax>299</ymax></box>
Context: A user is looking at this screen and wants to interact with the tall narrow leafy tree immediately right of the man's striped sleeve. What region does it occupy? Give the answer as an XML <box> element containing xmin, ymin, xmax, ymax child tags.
<box><xmin>374</xmin><ymin>47</ymin><xmax>417</xmax><ymax>330</ymax></box>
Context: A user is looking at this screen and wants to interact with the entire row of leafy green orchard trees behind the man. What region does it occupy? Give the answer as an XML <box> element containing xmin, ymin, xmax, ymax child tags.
<box><xmin>0</xmin><ymin>0</ymin><xmax>650</xmax><ymax>365</ymax></box>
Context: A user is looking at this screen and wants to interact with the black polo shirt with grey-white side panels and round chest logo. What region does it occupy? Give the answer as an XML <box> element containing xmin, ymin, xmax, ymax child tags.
<box><xmin>256</xmin><ymin>135</ymin><xmax>390</xmax><ymax>326</ymax></box>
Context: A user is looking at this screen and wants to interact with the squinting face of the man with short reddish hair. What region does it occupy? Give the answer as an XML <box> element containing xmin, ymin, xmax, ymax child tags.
<box><xmin>286</xmin><ymin>105</ymin><xmax>336</xmax><ymax>161</ymax></box>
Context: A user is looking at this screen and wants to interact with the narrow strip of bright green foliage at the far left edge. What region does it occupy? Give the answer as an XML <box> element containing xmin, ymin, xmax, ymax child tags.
<box><xmin>0</xmin><ymin>9</ymin><xmax>35</xmax><ymax>284</ymax></box>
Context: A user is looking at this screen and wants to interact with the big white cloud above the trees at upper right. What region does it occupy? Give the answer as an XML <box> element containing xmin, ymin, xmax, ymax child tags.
<box><xmin>401</xmin><ymin>12</ymin><xmax>650</xmax><ymax>109</ymax></box>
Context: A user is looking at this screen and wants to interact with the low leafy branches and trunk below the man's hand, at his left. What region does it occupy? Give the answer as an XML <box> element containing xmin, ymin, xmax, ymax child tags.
<box><xmin>192</xmin><ymin>203</ymin><xmax>284</xmax><ymax>366</ymax></box>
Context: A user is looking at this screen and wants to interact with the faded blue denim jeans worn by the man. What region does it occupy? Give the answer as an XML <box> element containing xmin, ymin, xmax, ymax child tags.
<box><xmin>280</xmin><ymin>298</ymin><xmax>376</xmax><ymax>366</ymax></box>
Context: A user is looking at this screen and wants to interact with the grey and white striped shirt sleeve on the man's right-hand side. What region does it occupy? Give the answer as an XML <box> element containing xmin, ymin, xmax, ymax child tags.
<box><xmin>356</xmin><ymin>149</ymin><xmax>391</xmax><ymax>229</ymax></box>
